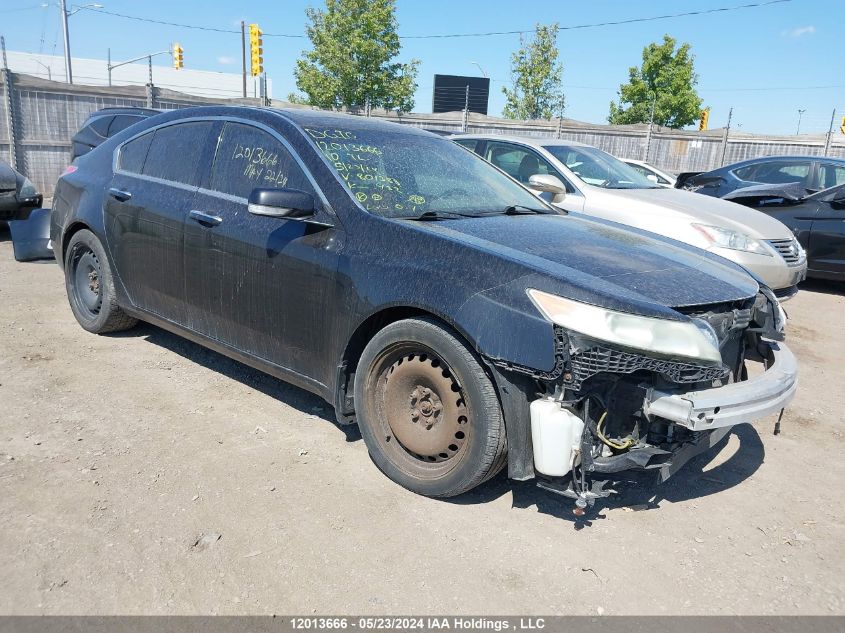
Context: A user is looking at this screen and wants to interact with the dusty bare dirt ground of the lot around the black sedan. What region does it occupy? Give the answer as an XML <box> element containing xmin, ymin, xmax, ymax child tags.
<box><xmin>0</xmin><ymin>230</ymin><xmax>845</xmax><ymax>614</ymax></box>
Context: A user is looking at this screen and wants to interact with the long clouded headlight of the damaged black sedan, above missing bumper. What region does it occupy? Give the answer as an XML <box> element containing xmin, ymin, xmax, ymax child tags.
<box><xmin>528</xmin><ymin>288</ymin><xmax>722</xmax><ymax>363</ymax></box>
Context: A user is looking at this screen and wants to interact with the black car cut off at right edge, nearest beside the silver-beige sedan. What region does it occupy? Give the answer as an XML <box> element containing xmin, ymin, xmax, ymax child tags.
<box><xmin>728</xmin><ymin>184</ymin><xmax>845</xmax><ymax>280</ymax></box>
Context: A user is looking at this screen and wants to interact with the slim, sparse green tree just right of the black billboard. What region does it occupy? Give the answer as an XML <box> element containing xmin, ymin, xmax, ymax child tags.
<box><xmin>502</xmin><ymin>24</ymin><xmax>566</xmax><ymax>119</ymax></box>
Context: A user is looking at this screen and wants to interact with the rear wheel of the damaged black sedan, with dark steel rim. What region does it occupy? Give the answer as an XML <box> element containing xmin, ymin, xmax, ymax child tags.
<box><xmin>65</xmin><ymin>229</ymin><xmax>138</xmax><ymax>334</ymax></box>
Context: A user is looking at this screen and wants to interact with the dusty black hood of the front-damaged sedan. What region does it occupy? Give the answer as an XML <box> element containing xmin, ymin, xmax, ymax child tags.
<box><xmin>412</xmin><ymin>213</ymin><xmax>758</xmax><ymax>315</ymax></box>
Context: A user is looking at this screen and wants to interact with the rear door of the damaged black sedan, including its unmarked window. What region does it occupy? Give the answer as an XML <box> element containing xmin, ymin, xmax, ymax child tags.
<box><xmin>105</xmin><ymin>121</ymin><xmax>214</xmax><ymax>324</ymax></box>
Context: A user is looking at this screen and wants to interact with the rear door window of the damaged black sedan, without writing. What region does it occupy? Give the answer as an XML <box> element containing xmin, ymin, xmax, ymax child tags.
<box><xmin>143</xmin><ymin>121</ymin><xmax>213</xmax><ymax>186</ymax></box>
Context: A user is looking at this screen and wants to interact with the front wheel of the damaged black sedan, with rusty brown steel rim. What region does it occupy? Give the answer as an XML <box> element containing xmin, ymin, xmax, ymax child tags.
<box><xmin>355</xmin><ymin>318</ymin><xmax>507</xmax><ymax>497</ymax></box>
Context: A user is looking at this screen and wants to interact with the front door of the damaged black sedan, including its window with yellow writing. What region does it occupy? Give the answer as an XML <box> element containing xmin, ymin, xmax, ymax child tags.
<box><xmin>184</xmin><ymin>121</ymin><xmax>342</xmax><ymax>379</ymax></box>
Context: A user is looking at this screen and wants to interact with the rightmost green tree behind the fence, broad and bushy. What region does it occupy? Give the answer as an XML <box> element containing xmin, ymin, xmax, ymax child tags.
<box><xmin>607</xmin><ymin>35</ymin><xmax>701</xmax><ymax>129</ymax></box>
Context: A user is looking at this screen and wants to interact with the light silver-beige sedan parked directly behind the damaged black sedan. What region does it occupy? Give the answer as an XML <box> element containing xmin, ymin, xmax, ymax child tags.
<box><xmin>453</xmin><ymin>135</ymin><xmax>807</xmax><ymax>299</ymax></box>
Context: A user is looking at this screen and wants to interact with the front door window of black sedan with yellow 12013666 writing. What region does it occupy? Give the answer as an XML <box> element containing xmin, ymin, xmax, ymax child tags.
<box><xmin>210</xmin><ymin>123</ymin><xmax>314</xmax><ymax>198</ymax></box>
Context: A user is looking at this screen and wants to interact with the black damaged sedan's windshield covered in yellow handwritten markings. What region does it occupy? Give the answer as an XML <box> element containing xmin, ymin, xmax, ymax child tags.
<box><xmin>304</xmin><ymin>125</ymin><xmax>551</xmax><ymax>218</ymax></box>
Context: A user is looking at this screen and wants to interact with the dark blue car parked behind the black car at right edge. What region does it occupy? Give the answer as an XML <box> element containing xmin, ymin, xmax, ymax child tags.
<box><xmin>675</xmin><ymin>156</ymin><xmax>845</xmax><ymax>198</ymax></box>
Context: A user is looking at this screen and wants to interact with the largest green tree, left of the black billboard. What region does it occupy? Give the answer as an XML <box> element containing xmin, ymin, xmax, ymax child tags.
<box><xmin>294</xmin><ymin>0</ymin><xmax>419</xmax><ymax>112</ymax></box>
